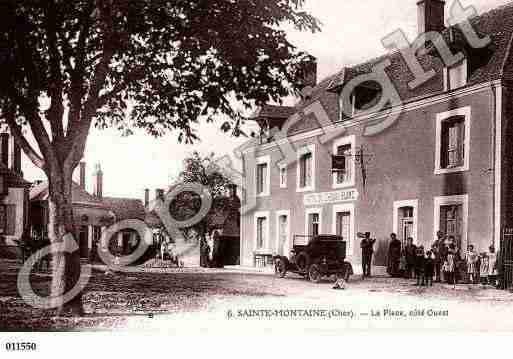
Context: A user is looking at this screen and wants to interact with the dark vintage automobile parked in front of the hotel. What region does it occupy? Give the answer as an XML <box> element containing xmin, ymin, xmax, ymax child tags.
<box><xmin>273</xmin><ymin>235</ymin><xmax>353</xmax><ymax>283</ymax></box>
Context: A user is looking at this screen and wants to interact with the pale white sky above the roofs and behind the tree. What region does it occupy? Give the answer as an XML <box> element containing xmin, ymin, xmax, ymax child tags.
<box><xmin>23</xmin><ymin>0</ymin><xmax>510</xmax><ymax>199</ymax></box>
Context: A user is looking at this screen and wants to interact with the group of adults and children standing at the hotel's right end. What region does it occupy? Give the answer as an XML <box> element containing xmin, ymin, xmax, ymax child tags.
<box><xmin>386</xmin><ymin>231</ymin><xmax>497</xmax><ymax>286</ymax></box>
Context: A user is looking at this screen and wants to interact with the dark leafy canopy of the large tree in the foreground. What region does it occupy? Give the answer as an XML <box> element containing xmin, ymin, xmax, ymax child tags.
<box><xmin>0</xmin><ymin>0</ymin><xmax>319</xmax><ymax>151</ymax></box>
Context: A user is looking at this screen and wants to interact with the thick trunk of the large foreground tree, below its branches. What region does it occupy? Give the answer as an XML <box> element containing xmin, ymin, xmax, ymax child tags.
<box><xmin>48</xmin><ymin>171</ymin><xmax>83</xmax><ymax>315</ymax></box>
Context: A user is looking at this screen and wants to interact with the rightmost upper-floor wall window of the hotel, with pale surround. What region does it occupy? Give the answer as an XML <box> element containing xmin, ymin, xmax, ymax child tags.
<box><xmin>435</xmin><ymin>107</ymin><xmax>470</xmax><ymax>174</ymax></box>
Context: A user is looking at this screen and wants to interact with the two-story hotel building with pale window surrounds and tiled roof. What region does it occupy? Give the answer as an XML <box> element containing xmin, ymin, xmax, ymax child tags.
<box><xmin>241</xmin><ymin>0</ymin><xmax>513</xmax><ymax>268</ymax></box>
